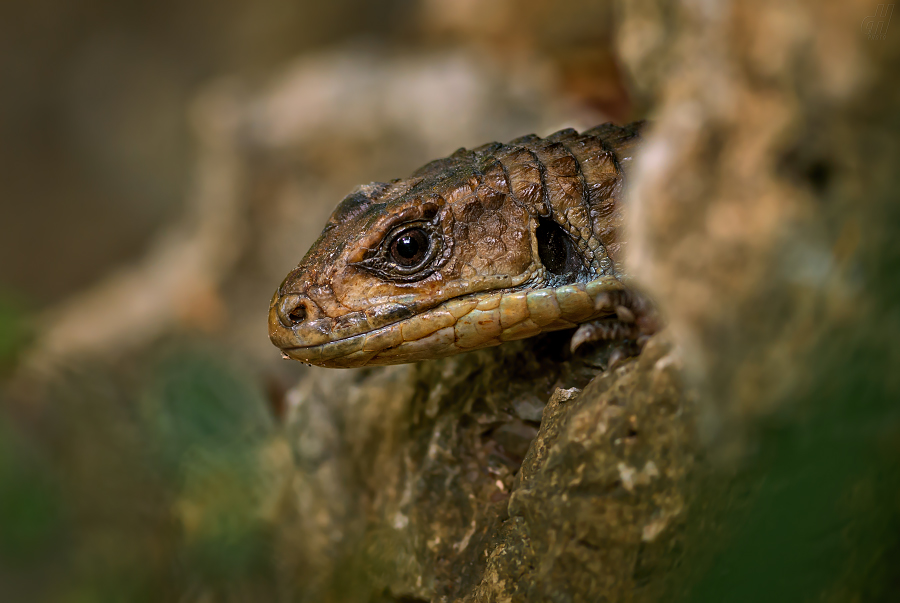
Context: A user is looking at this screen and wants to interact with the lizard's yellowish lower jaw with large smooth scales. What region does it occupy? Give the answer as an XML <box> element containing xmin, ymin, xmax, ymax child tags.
<box><xmin>282</xmin><ymin>276</ymin><xmax>625</xmax><ymax>368</ymax></box>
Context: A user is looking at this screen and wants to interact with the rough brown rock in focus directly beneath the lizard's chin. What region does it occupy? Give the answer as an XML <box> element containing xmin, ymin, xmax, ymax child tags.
<box><xmin>278</xmin><ymin>334</ymin><xmax>696</xmax><ymax>601</ymax></box>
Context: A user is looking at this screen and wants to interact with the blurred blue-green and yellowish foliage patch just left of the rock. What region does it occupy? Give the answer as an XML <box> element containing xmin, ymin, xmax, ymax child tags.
<box><xmin>141</xmin><ymin>353</ymin><xmax>272</xmax><ymax>584</ymax></box>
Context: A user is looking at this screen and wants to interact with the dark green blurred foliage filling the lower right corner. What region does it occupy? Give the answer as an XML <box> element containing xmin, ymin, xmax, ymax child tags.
<box><xmin>674</xmin><ymin>332</ymin><xmax>900</xmax><ymax>603</ymax></box>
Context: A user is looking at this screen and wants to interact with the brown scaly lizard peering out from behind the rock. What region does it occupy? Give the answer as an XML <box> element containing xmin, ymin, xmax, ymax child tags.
<box><xmin>268</xmin><ymin>122</ymin><xmax>655</xmax><ymax>367</ymax></box>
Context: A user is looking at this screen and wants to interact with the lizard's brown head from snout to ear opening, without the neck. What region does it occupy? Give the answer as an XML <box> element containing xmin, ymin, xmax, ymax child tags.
<box><xmin>269</xmin><ymin>125</ymin><xmax>640</xmax><ymax>367</ymax></box>
